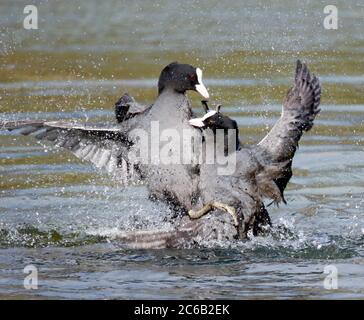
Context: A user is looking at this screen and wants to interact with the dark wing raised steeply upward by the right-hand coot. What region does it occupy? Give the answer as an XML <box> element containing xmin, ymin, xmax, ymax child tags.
<box><xmin>255</xmin><ymin>60</ymin><xmax>321</xmax><ymax>203</ymax></box>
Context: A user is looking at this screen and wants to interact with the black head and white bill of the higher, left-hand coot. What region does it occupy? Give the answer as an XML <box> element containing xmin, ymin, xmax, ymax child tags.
<box><xmin>158</xmin><ymin>62</ymin><xmax>209</xmax><ymax>99</ymax></box>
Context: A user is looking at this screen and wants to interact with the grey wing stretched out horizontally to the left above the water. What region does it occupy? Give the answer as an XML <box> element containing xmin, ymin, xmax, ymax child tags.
<box><xmin>0</xmin><ymin>121</ymin><xmax>139</xmax><ymax>182</ymax></box>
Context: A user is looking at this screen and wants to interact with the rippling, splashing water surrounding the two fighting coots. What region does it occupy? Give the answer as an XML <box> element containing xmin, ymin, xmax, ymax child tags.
<box><xmin>0</xmin><ymin>0</ymin><xmax>364</xmax><ymax>299</ymax></box>
